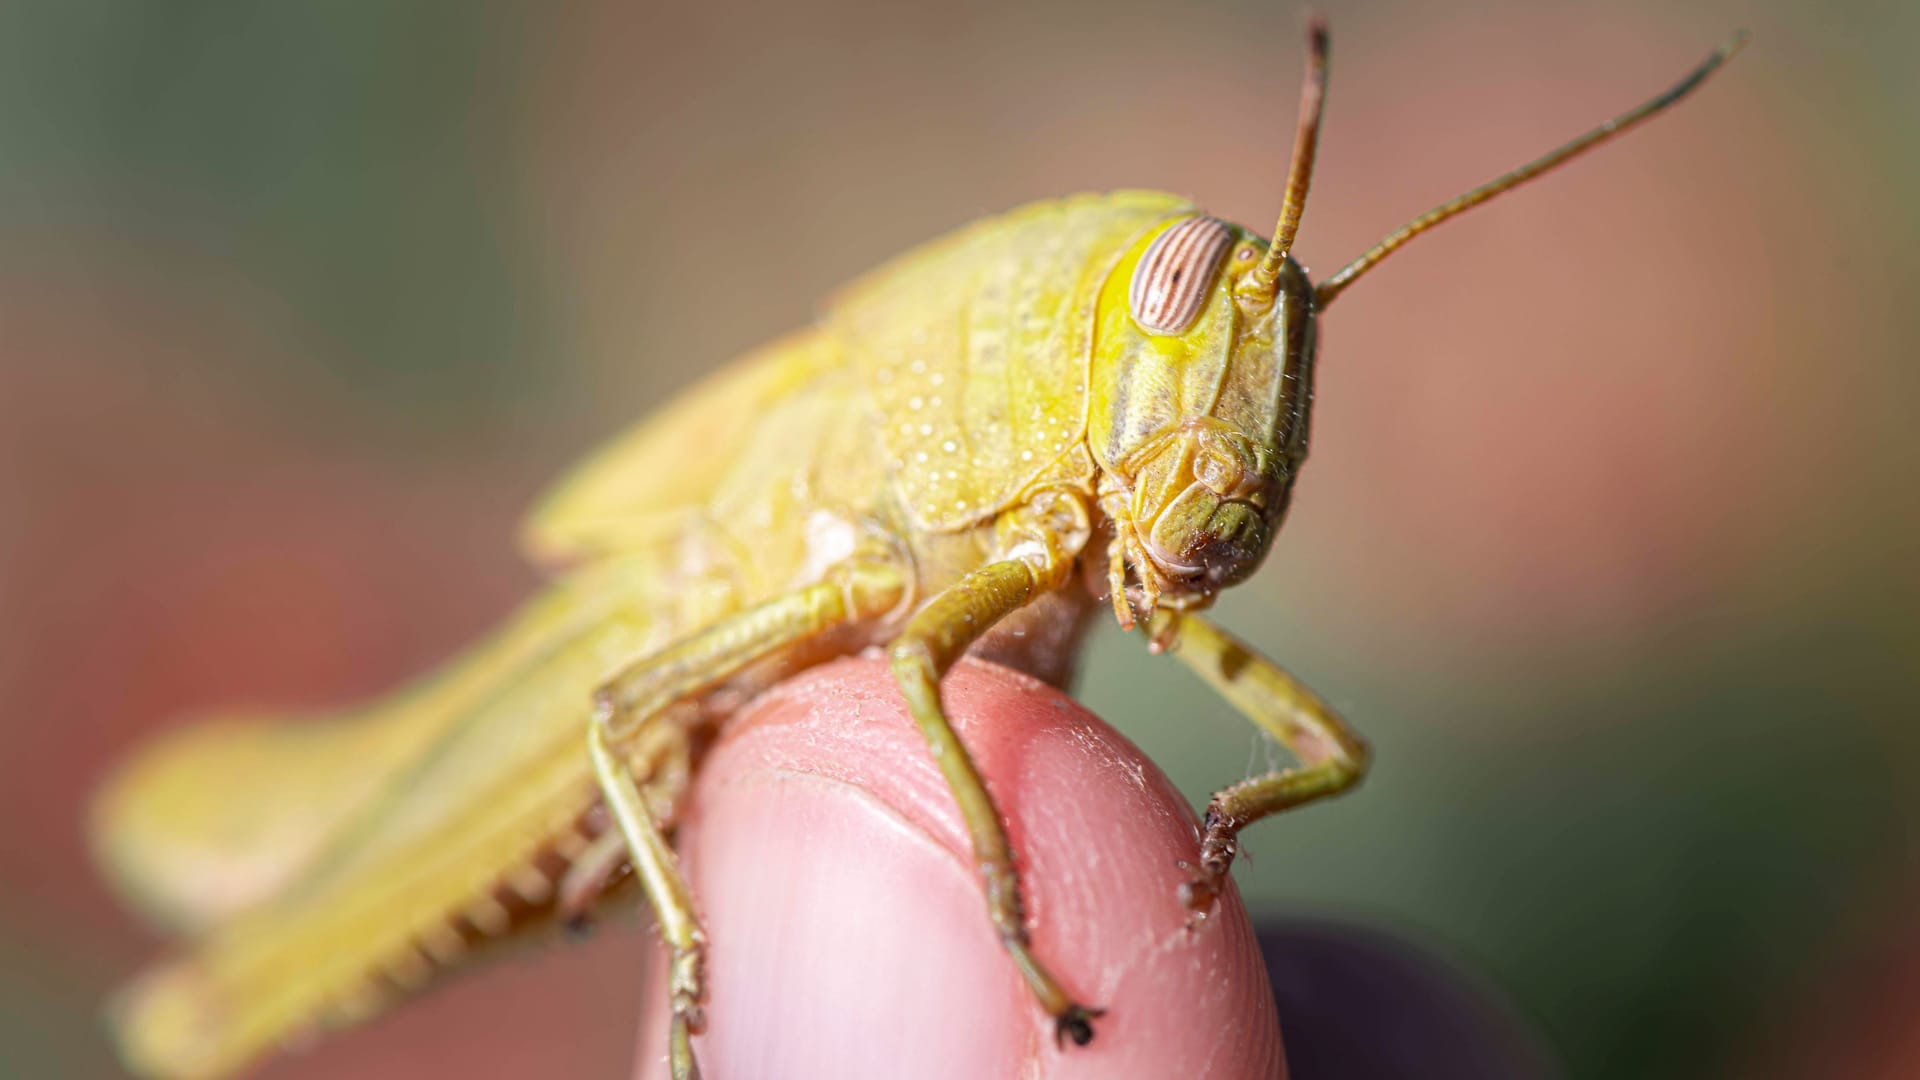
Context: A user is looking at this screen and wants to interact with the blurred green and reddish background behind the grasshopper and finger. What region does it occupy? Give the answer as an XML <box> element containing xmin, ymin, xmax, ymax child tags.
<box><xmin>0</xmin><ymin>0</ymin><xmax>1920</xmax><ymax>1078</ymax></box>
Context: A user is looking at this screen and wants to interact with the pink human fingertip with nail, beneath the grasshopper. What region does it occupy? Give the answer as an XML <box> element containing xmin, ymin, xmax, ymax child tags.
<box><xmin>634</xmin><ymin>657</ymin><xmax>1284</xmax><ymax>1080</ymax></box>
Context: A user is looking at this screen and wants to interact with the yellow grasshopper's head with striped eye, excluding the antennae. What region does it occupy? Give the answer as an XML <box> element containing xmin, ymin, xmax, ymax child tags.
<box><xmin>1089</xmin><ymin>217</ymin><xmax>1313</xmax><ymax>623</ymax></box>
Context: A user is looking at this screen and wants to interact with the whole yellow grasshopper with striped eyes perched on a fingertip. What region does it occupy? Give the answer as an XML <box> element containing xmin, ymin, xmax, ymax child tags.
<box><xmin>94</xmin><ymin>21</ymin><xmax>1743</xmax><ymax>1078</ymax></box>
